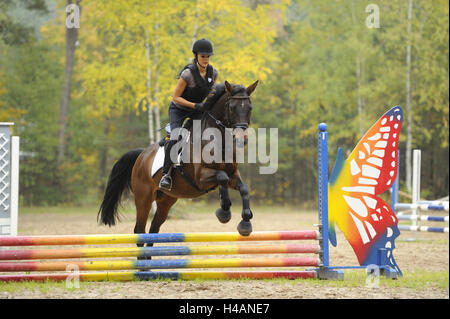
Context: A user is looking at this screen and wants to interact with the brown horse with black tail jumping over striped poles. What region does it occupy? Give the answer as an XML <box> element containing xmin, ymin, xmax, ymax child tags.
<box><xmin>98</xmin><ymin>81</ymin><xmax>258</xmax><ymax>246</ymax></box>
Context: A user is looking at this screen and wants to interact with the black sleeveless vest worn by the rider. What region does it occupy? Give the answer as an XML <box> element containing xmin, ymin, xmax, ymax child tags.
<box><xmin>180</xmin><ymin>63</ymin><xmax>214</xmax><ymax>103</ymax></box>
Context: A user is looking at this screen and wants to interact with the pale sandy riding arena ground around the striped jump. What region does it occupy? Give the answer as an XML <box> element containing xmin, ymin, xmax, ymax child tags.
<box><xmin>0</xmin><ymin>208</ymin><xmax>449</xmax><ymax>299</ymax></box>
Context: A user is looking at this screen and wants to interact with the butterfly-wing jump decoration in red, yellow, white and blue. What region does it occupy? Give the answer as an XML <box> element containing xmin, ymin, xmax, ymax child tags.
<box><xmin>328</xmin><ymin>106</ymin><xmax>403</xmax><ymax>275</ymax></box>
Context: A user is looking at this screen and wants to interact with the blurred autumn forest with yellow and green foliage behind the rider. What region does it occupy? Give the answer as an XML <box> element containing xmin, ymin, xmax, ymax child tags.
<box><xmin>0</xmin><ymin>0</ymin><xmax>449</xmax><ymax>207</ymax></box>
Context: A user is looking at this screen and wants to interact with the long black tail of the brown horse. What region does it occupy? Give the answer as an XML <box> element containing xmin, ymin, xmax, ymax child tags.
<box><xmin>97</xmin><ymin>148</ymin><xmax>144</xmax><ymax>226</ymax></box>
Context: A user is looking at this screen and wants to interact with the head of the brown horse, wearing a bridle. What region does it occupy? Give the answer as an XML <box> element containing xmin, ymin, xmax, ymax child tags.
<box><xmin>224</xmin><ymin>81</ymin><xmax>258</xmax><ymax>146</ymax></box>
